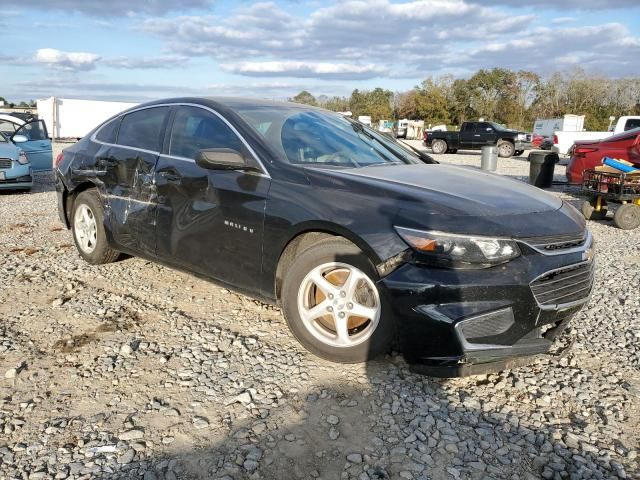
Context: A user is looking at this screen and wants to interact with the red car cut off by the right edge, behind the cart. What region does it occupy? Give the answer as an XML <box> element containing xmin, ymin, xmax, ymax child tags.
<box><xmin>567</xmin><ymin>128</ymin><xmax>640</xmax><ymax>183</ymax></box>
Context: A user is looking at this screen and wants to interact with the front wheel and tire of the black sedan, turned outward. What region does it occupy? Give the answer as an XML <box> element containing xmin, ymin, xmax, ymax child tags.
<box><xmin>282</xmin><ymin>238</ymin><xmax>395</xmax><ymax>363</ymax></box>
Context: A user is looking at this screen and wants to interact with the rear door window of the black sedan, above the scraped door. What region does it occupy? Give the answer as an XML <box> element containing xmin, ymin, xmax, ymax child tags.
<box><xmin>117</xmin><ymin>107</ymin><xmax>169</xmax><ymax>152</ymax></box>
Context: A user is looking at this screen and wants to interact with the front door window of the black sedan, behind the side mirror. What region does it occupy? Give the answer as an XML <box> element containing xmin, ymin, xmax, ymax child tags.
<box><xmin>169</xmin><ymin>107</ymin><xmax>244</xmax><ymax>159</ymax></box>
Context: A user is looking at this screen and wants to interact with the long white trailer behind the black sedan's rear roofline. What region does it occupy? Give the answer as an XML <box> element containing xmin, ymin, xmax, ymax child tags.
<box><xmin>37</xmin><ymin>97</ymin><xmax>137</xmax><ymax>139</ymax></box>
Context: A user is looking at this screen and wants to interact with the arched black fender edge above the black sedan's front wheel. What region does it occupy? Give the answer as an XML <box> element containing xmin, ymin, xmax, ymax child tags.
<box><xmin>273</xmin><ymin>222</ymin><xmax>380</xmax><ymax>301</ymax></box>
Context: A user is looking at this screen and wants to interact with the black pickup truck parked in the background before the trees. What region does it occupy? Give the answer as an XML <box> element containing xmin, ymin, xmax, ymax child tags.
<box><xmin>424</xmin><ymin>122</ymin><xmax>531</xmax><ymax>158</ymax></box>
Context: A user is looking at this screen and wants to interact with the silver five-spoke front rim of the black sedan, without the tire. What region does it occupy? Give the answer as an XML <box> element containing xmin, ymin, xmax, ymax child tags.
<box><xmin>298</xmin><ymin>262</ymin><xmax>381</xmax><ymax>347</ymax></box>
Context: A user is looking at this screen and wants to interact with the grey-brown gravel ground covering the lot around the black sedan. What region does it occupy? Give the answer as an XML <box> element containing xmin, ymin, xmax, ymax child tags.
<box><xmin>0</xmin><ymin>143</ymin><xmax>640</xmax><ymax>480</ymax></box>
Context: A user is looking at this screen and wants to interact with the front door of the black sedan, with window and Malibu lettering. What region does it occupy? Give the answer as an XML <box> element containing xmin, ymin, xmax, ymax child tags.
<box><xmin>155</xmin><ymin>106</ymin><xmax>271</xmax><ymax>291</ymax></box>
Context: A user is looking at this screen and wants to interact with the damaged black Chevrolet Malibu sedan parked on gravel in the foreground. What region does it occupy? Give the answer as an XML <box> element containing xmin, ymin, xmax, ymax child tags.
<box><xmin>55</xmin><ymin>98</ymin><xmax>594</xmax><ymax>376</ymax></box>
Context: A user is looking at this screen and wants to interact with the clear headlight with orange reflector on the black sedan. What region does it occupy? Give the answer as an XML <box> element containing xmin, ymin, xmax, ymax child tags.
<box><xmin>395</xmin><ymin>227</ymin><xmax>520</xmax><ymax>269</ymax></box>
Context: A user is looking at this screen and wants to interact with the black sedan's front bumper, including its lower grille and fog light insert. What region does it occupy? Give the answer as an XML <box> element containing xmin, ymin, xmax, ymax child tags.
<box><xmin>380</xmin><ymin>236</ymin><xmax>594</xmax><ymax>377</ymax></box>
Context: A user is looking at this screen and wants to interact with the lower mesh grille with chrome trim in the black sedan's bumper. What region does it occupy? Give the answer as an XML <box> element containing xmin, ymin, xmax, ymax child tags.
<box><xmin>530</xmin><ymin>262</ymin><xmax>594</xmax><ymax>308</ymax></box>
